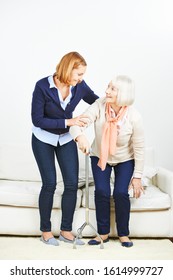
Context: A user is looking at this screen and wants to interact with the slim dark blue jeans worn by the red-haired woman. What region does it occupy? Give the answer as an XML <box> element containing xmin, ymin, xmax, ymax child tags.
<box><xmin>32</xmin><ymin>135</ymin><xmax>79</xmax><ymax>232</ymax></box>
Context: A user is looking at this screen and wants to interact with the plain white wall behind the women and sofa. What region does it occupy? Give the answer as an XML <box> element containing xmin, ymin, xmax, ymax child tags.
<box><xmin>0</xmin><ymin>0</ymin><xmax>173</xmax><ymax>170</ymax></box>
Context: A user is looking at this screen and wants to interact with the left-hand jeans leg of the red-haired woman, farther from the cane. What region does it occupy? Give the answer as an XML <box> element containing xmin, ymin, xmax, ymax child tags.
<box><xmin>32</xmin><ymin>135</ymin><xmax>56</xmax><ymax>232</ymax></box>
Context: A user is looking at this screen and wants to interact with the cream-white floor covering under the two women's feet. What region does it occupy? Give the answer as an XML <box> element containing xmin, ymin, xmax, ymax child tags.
<box><xmin>0</xmin><ymin>236</ymin><xmax>173</xmax><ymax>260</ymax></box>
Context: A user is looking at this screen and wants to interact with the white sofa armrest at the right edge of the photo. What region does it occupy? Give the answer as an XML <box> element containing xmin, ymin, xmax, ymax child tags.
<box><xmin>153</xmin><ymin>167</ymin><xmax>173</xmax><ymax>201</ymax></box>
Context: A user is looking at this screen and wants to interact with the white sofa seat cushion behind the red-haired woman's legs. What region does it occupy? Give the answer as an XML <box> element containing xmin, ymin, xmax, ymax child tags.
<box><xmin>0</xmin><ymin>180</ymin><xmax>82</xmax><ymax>209</ymax></box>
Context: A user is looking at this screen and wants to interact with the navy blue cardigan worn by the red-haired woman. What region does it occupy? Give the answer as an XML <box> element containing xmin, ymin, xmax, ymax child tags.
<box><xmin>31</xmin><ymin>77</ymin><xmax>98</xmax><ymax>134</ymax></box>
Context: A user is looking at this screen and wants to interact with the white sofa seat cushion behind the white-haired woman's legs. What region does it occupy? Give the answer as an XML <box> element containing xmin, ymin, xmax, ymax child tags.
<box><xmin>82</xmin><ymin>185</ymin><xmax>171</xmax><ymax>211</ymax></box>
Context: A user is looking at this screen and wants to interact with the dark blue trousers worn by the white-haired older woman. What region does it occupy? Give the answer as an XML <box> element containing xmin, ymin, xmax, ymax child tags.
<box><xmin>91</xmin><ymin>156</ymin><xmax>134</xmax><ymax>236</ymax></box>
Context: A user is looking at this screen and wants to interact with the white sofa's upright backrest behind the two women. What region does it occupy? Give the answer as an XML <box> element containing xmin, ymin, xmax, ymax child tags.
<box><xmin>0</xmin><ymin>144</ymin><xmax>154</xmax><ymax>182</ymax></box>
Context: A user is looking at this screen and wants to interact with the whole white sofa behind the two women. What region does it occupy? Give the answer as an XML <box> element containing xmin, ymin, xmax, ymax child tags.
<box><xmin>0</xmin><ymin>144</ymin><xmax>173</xmax><ymax>238</ymax></box>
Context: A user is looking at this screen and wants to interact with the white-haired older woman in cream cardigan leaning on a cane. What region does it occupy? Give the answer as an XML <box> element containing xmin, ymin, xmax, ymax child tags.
<box><xmin>70</xmin><ymin>76</ymin><xmax>144</xmax><ymax>247</ymax></box>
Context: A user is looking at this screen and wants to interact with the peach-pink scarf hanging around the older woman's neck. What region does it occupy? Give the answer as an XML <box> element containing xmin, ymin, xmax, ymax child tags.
<box><xmin>98</xmin><ymin>103</ymin><xmax>127</xmax><ymax>171</ymax></box>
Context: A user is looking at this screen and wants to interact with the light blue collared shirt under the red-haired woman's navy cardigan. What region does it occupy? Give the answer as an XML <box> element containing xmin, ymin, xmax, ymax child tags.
<box><xmin>32</xmin><ymin>75</ymin><xmax>72</xmax><ymax>147</ymax></box>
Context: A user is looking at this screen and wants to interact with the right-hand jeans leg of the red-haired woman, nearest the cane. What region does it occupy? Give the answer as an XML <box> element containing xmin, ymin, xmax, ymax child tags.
<box><xmin>56</xmin><ymin>140</ymin><xmax>79</xmax><ymax>231</ymax></box>
